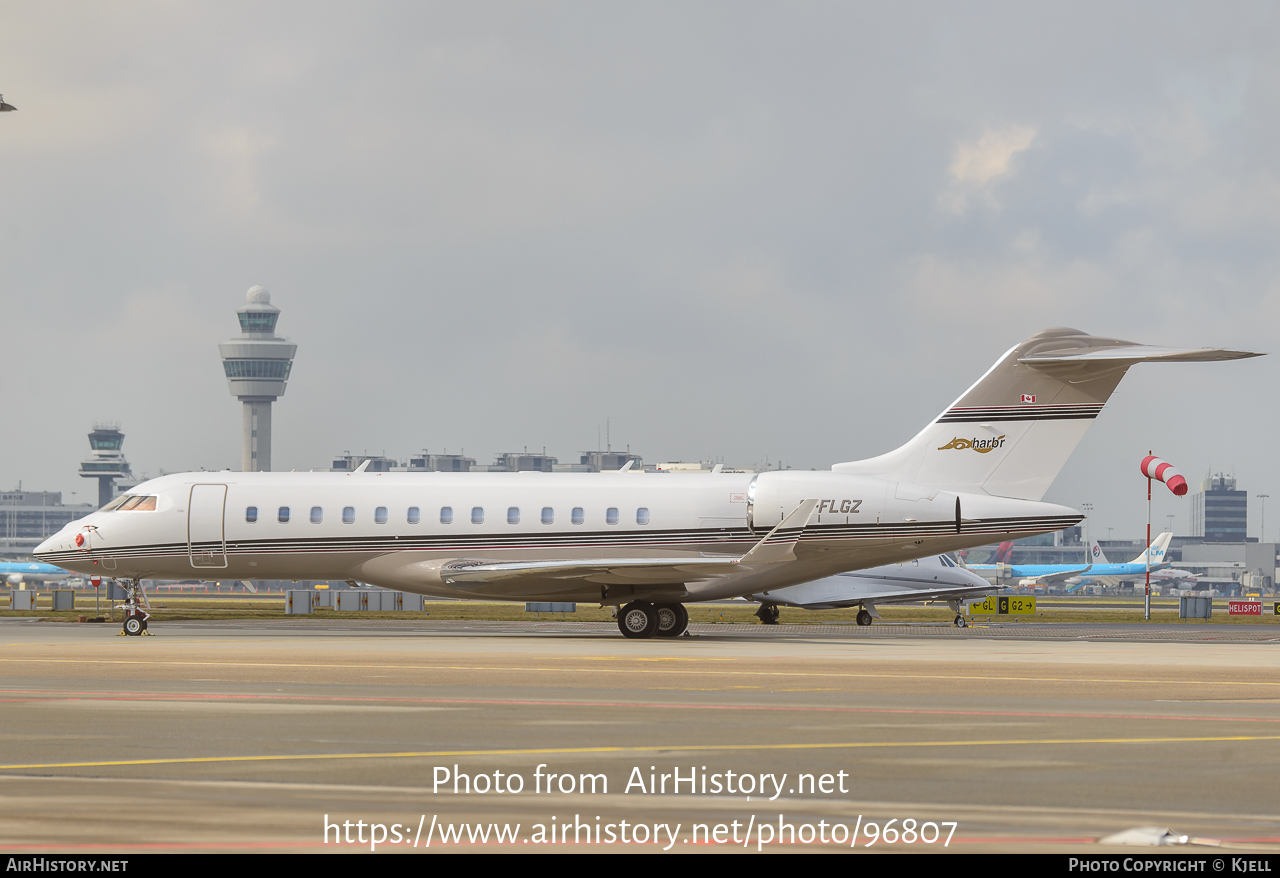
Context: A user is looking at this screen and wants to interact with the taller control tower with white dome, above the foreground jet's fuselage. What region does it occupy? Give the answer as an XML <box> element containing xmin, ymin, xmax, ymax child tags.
<box><xmin>218</xmin><ymin>287</ymin><xmax>298</xmax><ymax>472</ymax></box>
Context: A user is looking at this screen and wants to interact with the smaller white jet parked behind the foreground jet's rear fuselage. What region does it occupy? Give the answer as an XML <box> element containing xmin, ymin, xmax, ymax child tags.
<box><xmin>748</xmin><ymin>555</ymin><xmax>1000</xmax><ymax>628</ymax></box>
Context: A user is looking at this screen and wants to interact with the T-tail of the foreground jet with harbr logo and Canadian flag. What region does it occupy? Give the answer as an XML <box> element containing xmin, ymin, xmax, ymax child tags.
<box><xmin>831</xmin><ymin>328</ymin><xmax>1260</xmax><ymax>500</ymax></box>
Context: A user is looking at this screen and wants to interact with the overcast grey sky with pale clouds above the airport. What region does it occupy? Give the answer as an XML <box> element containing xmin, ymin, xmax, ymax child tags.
<box><xmin>0</xmin><ymin>0</ymin><xmax>1280</xmax><ymax>539</ymax></box>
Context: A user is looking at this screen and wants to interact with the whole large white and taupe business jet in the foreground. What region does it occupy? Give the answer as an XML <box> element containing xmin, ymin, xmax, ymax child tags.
<box><xmin>36</xmin><ymin>329</ymin><xmax>1257</xmax><ymax>637</ymax></box>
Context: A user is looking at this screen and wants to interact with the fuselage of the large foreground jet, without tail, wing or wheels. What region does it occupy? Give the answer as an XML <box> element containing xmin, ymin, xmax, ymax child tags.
<box><xmin>36</xmin><ymin>471</ymin><xmax>1080</xmax><ymax>603</ymax></box>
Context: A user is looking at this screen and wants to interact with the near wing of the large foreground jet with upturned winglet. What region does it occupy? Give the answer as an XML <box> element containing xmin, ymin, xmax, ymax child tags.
<box><xmin>440</xmin><ymin>499</ymin><xmax>818</xmax><ymax>594</ymax></box>
